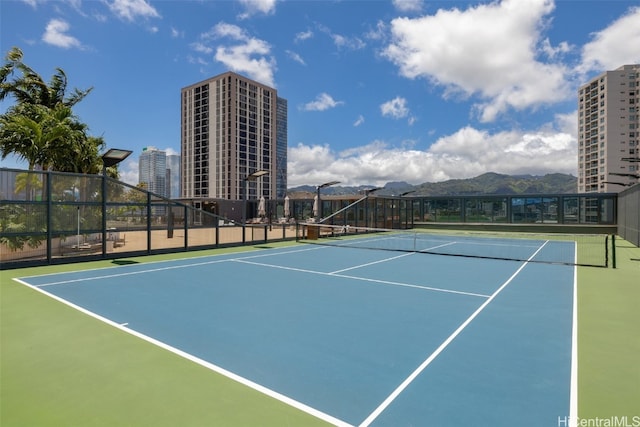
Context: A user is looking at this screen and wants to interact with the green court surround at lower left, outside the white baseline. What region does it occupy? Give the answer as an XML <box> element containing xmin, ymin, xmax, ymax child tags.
<box><xmin>0</xmin><ymin>246</ymin><xmax>326</xmax><ymax>427</ymax></box>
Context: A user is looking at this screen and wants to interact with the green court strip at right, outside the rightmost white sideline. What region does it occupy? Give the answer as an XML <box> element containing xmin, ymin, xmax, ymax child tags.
<box><xmin>578</xmin><ymin>239</ymin><xmax>640</xmax><ymax>425</ymax></box>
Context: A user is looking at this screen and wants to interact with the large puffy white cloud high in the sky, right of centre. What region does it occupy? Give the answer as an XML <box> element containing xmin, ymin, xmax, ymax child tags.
<box><xmin>383</xmin><ymin>0</ymin><xmax>571</xmax><ymax>122</ymax></box>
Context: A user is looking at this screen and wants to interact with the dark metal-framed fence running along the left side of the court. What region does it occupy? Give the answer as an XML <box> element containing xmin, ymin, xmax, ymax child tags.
<box><xmin>0</xmin><ymin>169</ymin><xmax>295</xmax><ymax>269</ymax></box>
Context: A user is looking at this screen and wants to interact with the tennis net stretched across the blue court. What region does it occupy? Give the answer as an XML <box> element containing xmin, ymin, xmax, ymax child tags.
<box><xmin>297</xmin><ymin>223</ymin><xmax>609</xmax><ymax>267</ymax></box>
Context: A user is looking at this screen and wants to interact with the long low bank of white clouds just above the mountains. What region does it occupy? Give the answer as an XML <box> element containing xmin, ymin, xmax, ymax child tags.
<box><xmin>288</xmin><ymin>122</ymin><xmax>577</xmax><ymax>187</ymax></box>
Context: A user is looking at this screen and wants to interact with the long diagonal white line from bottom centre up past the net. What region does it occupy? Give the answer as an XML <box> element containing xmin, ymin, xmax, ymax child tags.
<box><xmin>359</xmin><ymin>240</ymin><xmax>548</xmax><ymax>427</ymax></box>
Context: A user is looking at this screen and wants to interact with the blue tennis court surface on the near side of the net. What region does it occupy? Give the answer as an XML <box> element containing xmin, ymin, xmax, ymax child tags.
<box><xmin>21</xmin><ymin>244</ymin><xmax>575</xmax><ymax>426</ymax></box>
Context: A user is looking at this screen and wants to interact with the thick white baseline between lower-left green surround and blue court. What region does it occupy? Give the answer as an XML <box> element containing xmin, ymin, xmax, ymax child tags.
<box><xmin>13</xmin><ymin>279</ymin><xmax>352</xmax><ymax>427</ymax></box>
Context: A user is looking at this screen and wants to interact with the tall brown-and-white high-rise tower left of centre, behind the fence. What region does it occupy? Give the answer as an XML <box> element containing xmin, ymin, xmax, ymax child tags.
<box><xmin>180</xmin><ymin>72</ymin><xmax>287</xmax><ymax>206</ymax></box>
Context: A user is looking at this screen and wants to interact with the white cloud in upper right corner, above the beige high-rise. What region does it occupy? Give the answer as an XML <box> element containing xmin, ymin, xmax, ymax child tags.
<box><xmin>579</xmin><ymin>7</ymin><xmax>640</xmax><ymax>73</ymax></box>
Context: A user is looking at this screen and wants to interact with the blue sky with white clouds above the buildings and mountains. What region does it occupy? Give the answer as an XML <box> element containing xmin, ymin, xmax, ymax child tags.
<box><xmin>0</xmin><ymin>0</ymin><xmax>640</xmax><ymax>187</ymax></box>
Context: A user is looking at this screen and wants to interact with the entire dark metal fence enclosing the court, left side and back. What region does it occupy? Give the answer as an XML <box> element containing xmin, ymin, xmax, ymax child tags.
<box><xmin>0</xmin><ymin>168</ymin><xmax>624</xmax><ymax>269</ymax></box>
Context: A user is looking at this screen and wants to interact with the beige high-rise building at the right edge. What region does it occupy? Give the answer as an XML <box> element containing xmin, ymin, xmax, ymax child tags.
<box><xmin>578</xmin><ymin>64</ymin><xmax>640</xmax><ymax>193</ymax></box>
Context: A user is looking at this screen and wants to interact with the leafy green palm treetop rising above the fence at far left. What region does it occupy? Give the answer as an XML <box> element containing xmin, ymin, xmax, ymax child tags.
<box><xmin>0</xmin><ymin>47</ymin><xmax>104</xmax><ymax>176</ymax></box>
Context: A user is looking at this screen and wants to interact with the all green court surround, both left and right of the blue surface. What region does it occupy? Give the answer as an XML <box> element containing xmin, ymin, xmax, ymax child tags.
<box><xmin>0</xmin><ymin>240</ymin><xmax>640</xmax><ymax>427</ymax></box>
